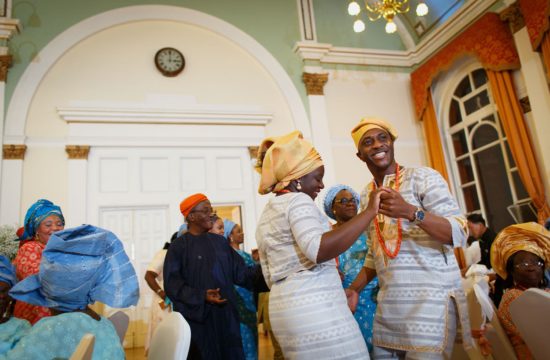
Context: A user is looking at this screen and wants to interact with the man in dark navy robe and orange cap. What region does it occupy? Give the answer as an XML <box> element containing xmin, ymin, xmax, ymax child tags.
<box><xmin>163</xmin><ymin>194</ymin><xmax>259</xmax><ymax>360</ymax></box>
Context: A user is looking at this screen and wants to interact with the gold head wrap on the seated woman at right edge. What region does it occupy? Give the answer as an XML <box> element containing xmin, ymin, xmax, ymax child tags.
<box><xmin>491</xmin><ymin>222</ymin><xmax>550</xmax><ymax>279</ymax></box>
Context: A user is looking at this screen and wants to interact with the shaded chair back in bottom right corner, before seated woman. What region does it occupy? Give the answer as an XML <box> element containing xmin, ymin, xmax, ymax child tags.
<box><xmin>510</xmin><ymin>288</ymin><xmax>550</xmax><ymax>359</ymax></box>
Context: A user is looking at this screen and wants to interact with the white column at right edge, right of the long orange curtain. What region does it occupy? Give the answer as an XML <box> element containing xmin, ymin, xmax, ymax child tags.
<box><xmin>514</xmin><ymin>27</ymin><xmax>550</xmax><ymax>199</ymax></box>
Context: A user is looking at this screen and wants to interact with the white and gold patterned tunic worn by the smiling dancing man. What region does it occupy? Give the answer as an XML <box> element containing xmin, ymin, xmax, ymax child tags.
<box><xmin>361</xmin><ymin>167</ymin><xmax>472</xmax><ymax>353</ymax></box>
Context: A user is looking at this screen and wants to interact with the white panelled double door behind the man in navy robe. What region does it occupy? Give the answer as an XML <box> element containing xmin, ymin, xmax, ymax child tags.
<box><xmin>87</xmin><ymin>147</ymin><xmax>256</xmax><ymax>347</ymax></box>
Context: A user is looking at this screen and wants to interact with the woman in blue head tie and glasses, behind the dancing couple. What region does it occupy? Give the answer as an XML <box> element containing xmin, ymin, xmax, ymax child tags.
<box><xmin>323</xmin><ymin>185</ymin><xmax>378</xmax><ymax>351</ymax></box>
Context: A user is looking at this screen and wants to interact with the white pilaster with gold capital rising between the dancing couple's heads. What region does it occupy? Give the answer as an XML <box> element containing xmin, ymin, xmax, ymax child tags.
<box><xmin>302</xmin><ymin>72</ymin><xmax>336</xmax><ymax>186</ymax></box>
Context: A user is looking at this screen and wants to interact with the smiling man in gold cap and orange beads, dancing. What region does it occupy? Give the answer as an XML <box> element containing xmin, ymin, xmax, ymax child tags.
<box><xmin>350</xmin><ymin>118</ymin><xmax>472</xmax><ymax>359</ymax></box>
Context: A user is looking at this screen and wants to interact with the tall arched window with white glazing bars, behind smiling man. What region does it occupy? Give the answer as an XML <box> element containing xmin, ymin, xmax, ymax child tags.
<box><xmin>446</xmin><ymin>69</ymin><xmax>536</xmax><ymax>231</ymax></box>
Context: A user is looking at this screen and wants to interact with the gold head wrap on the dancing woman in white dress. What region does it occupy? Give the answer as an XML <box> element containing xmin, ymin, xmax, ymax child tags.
<box><xmin>256</xmin><ymin>131</ymin><xmax>323</xmax><ymax>195</ymax></box>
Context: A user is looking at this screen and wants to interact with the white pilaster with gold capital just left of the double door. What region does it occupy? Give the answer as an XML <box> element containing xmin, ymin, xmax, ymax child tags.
<box><xmin>65</xmin><ymin>145</ymin><xmax>90</xmax><ymax>227</ymax></box>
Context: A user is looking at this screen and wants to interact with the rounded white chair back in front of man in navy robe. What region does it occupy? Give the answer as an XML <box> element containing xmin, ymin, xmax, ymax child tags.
<box><xmin>149</xmin><ymin>311</ymin><xmax>191</xmax><ymax>360</ymax></box>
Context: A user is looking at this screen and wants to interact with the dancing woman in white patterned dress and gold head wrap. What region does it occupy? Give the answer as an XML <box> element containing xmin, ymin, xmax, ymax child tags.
<box><xmin>256</xmin><ymin>131</ymin><xmax>383</xmax><ymax>360</ymax></box>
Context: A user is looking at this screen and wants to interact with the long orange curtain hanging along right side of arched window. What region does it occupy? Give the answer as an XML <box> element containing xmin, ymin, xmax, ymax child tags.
<box><xmin>487</xmin><ymin>70</ymin><xmax>550</xmax><ymax>224</ymax></box>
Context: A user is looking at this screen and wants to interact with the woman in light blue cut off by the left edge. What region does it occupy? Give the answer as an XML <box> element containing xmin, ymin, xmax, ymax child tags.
<box><xmin>0</xmin><ymin>255</ymin><xmax>31</xmax><ymax>356</ymax></box>
